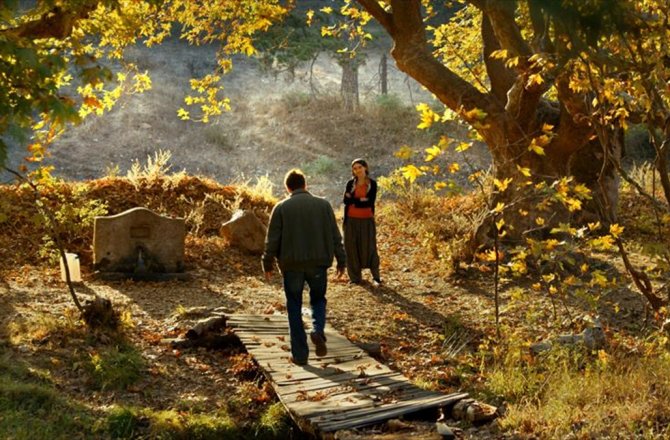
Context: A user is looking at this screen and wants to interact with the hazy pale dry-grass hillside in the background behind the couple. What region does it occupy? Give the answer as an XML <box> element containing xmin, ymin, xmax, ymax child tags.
<box><xmin>10</xmin><ymin>39</ymin><xmax>487</xmax><ymax>203</ymax></box>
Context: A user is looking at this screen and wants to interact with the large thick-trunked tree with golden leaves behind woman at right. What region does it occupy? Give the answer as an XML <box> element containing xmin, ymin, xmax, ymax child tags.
<box><xmin>345</xmin><ymin>0</ymin><xmax>670</xmax><ymax>244</ymax></box>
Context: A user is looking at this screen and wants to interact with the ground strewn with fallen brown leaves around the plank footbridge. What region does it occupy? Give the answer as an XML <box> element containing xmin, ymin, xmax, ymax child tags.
<box><xmin>0</xmin><ymin>171</ymin><xmax>644</xmax><ymax>439</ymax></box>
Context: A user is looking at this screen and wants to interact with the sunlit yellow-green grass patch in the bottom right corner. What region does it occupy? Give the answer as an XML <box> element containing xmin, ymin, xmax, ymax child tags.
<box><xmin>488</xmin><ymin>348</ymin><xmax>670</xmax><ymax>438</ymax></box>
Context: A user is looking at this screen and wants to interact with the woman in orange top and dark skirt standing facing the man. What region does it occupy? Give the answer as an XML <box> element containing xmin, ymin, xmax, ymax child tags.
<box><xmin>344</xmin><ymin>159</ymin><xmax>381</xmax><ymax>285</ymax></box>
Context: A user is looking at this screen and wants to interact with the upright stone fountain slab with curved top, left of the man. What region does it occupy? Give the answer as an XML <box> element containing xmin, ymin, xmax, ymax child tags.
<box><xmin>93</xmin><ymin>208</ymin><xmax>186</xmax><ymax>280</ymax></box>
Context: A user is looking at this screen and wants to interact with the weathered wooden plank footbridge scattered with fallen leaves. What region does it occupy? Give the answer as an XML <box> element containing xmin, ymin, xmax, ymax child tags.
<box><xmin>227</xmin><ymin>315</ymin><xmax>467</xmax><ymax>433</ymax></box>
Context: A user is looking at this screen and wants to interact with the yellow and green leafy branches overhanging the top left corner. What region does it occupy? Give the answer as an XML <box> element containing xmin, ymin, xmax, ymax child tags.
<box><xmin>0</xmin><ymin>0</ymin><xmax>286</xmax><ymax>163</ymax></box>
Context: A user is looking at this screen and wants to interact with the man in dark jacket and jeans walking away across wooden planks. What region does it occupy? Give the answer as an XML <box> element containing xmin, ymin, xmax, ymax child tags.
<box><xmin>261</xmin><ymin>169</ymin><xmax>346</xmax><ymax>365</ymax></box>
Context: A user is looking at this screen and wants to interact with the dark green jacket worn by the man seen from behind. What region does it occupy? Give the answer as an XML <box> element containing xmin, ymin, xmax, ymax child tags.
<box><xmin>261</xmin><ymin>189</ymin><xmax>346</xmax><ymax>272</ymax></box>
